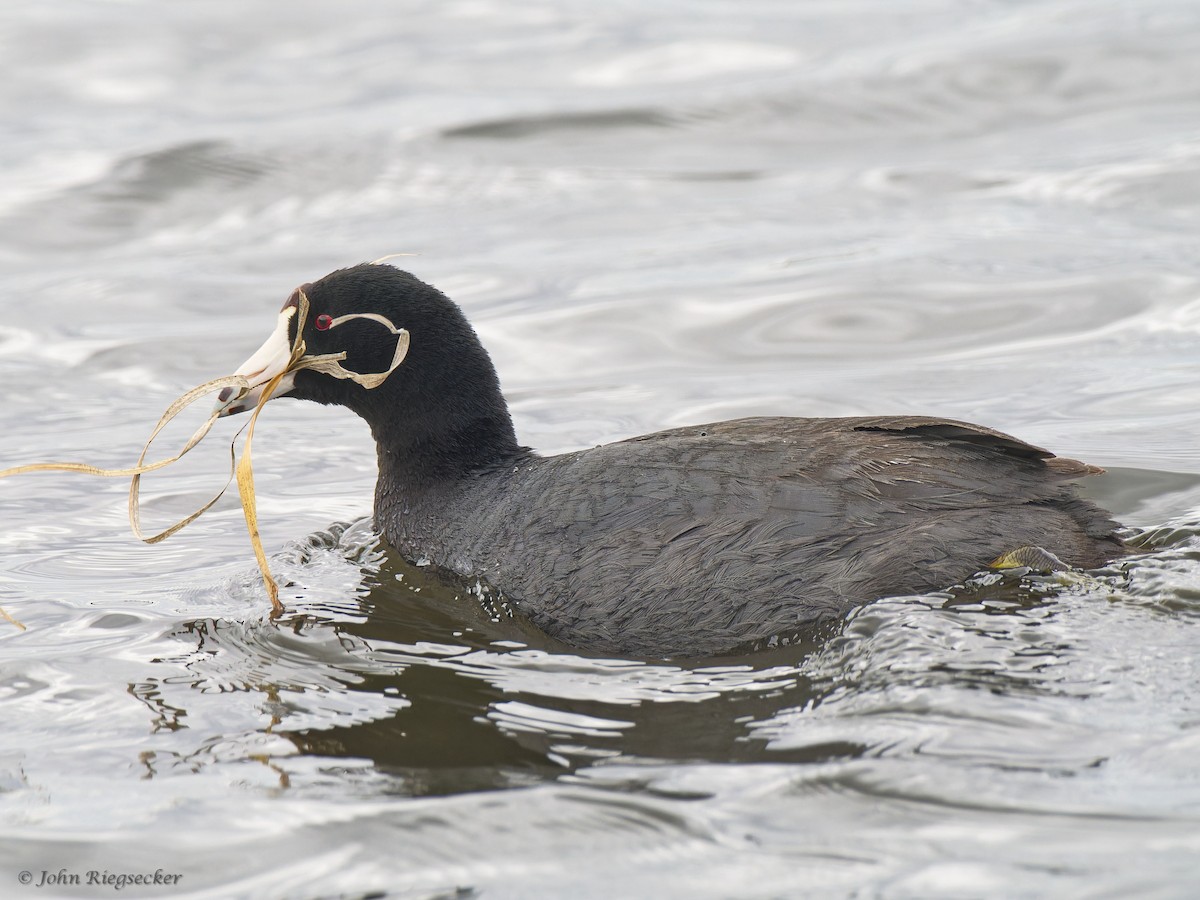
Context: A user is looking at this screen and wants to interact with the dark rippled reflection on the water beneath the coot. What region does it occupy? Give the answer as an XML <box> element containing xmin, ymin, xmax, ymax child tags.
<box><xmin>131</xmin><ymin>522</ymin><xmax>840</xmax><ymax>794</ymax></box>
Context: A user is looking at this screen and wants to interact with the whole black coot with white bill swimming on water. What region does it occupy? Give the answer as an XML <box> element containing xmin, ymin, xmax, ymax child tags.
<box><xmin>218</xmin><ymin>264</ymin><xmax>1126</xmax><ymax>656</ymax></box>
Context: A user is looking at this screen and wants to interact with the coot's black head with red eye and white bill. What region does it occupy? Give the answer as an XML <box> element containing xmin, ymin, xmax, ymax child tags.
<box><xmin>226</xmin><ymin>264</ymin><xmax>517</xmax><ymax>482</ymax></box>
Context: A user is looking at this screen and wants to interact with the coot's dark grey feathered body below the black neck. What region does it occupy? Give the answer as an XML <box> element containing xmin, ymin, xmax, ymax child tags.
<box><xmin>376</xmin><ymin>418</ymin><xmax>1121</xmax><ymax>656</ymax></box>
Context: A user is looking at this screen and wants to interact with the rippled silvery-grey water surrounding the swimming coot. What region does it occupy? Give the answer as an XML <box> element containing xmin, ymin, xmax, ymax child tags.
<box><xmin>0</xmin><ymin>0</ymin><xmax>1200</xmax><ymax>898</ymax></box>
